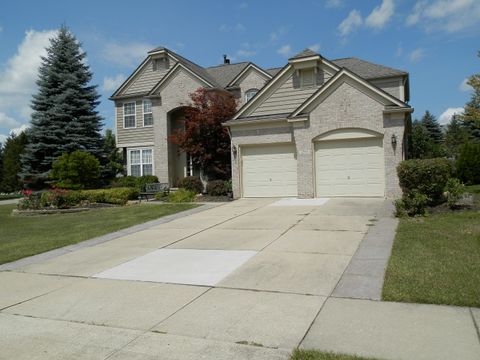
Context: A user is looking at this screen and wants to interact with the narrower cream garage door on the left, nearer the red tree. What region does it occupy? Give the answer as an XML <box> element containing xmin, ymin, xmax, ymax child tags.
<box><xmin>242</xmin><ymin>145</ymin><xmax>297</xmax><ymax>197</ymax></box>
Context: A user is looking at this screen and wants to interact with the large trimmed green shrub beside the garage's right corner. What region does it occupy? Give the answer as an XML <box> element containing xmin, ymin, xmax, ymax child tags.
<box><xmin>397</xmin><ymin>158</ymin><xmax>453</xmax><ymax>203</ymax></box>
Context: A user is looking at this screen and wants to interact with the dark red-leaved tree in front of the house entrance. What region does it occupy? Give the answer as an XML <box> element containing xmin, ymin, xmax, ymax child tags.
<box><xmin>169</xmin><ymin>88</ymin><xmax>237</xmax><ymax>180</ymax></box>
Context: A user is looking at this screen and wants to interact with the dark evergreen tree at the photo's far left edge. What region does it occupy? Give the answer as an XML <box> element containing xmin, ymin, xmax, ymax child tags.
<box><xmin>0</xmin><ymin>132</ymin><xmax>28</xmax><ymax>192</ymax></box>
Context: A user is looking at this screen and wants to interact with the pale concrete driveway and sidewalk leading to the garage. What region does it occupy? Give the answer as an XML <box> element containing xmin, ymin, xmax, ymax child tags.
<box><xmin>0</xmin><ymin>199</ymin><xmax>480</xmax><ymax>359</ymax></box>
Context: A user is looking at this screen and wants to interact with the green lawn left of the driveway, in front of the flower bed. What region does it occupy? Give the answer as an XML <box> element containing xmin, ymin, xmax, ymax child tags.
<box><xmin>0</xmin><ymin>204</ymin><xmax>198</xmax><ymax>264</ymax></box>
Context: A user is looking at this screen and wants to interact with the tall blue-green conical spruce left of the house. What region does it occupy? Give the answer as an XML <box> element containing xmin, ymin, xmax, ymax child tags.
<box><xmin>22</xmin><ymin>26</ymin><xmax>102</xmax><ymax>182</ymax></box>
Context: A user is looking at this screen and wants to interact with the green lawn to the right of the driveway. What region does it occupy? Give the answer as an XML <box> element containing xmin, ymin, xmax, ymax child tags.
<box><xmin>382</xmin><ymin>211</ymin><xmax>480</xmax><ymax>307</ymax></box>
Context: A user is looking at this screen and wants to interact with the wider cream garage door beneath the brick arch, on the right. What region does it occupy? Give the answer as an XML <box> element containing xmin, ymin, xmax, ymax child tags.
<box><xmin>315</xmin><ymin>138</ymin><xmax>385</xmax><ymax>197</ymax></box>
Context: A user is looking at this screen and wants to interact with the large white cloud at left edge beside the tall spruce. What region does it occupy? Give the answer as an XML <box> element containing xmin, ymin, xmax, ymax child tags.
<box><xmin>0</xmin><ymin>30</ymin><xmax>56</xmax><ymax>136</ymax></box>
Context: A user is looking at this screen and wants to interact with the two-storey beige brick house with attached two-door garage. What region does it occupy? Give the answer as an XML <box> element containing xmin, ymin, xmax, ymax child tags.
<box><xmin>111</xmin><ymin>48</ymin><xmax>413</xmax><ymax>198</ymax></box>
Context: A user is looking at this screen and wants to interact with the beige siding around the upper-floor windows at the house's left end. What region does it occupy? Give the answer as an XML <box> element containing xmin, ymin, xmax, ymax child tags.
<box><xmin>115</xmin><ymin>100</ymin><xmax>155</xmax><ymax>145</ymax></box>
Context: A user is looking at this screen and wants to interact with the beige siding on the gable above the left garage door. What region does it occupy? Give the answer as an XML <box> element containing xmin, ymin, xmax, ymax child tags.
<box><xmin>251</xmin><ymin>75</ymin><xmax>318</xmax><ymax>116</ymax></box>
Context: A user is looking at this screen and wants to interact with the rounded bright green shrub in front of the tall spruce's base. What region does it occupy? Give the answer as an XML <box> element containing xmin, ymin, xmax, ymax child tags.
<box><xmin>50</xmin><ymin>150</ymin><xmax>100</xmax><ymax>189</ymax></box>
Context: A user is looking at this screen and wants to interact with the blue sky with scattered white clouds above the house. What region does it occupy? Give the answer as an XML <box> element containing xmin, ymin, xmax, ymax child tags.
<box><xmin>0</xmin><ymin>0</ymin><xmax>480</xmax><ymax>141</ymax></box>
